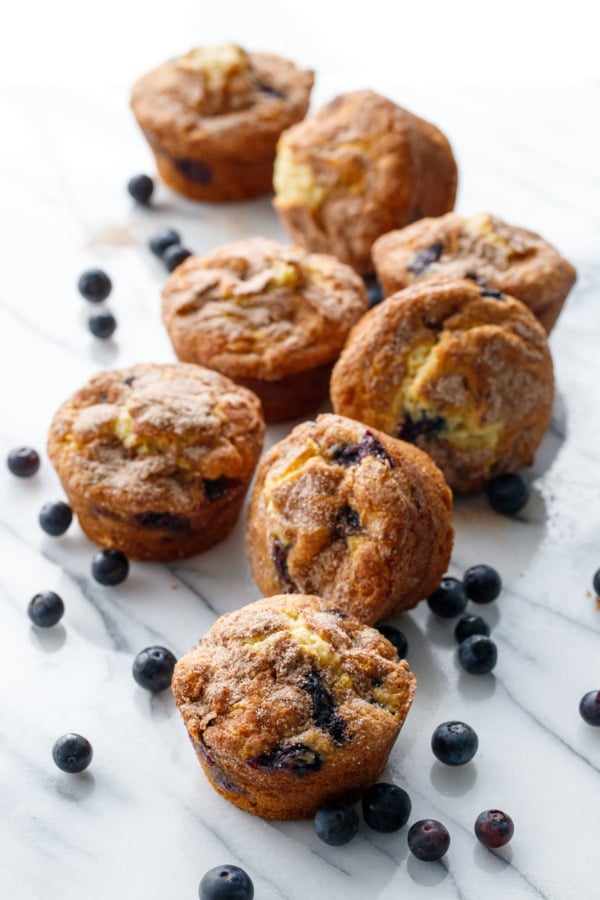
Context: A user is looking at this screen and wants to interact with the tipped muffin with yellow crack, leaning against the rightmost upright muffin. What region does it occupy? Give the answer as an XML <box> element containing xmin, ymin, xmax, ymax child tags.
<box><xmin>331</xmin><ymin>278</ymin><xmax>554</xmax><ymax>491</ymax></box>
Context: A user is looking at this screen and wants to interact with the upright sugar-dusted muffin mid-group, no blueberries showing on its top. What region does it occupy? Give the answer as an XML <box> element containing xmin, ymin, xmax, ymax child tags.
<box><xmin>162</xmin><ymin>237</ymin><xmax>369</xmax><ymax>422</ymax></box>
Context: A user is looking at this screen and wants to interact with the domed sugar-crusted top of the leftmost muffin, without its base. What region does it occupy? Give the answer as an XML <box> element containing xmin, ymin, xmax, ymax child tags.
<box><xmin>48</xmin><ymin>363</ymin><xmax>264</xmax><ymax>513</ymax></box>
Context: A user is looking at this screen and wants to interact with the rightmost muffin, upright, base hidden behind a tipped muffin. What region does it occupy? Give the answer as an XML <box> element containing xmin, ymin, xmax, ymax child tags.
<box><xmin>371</xmin><ymin>213</ymin><xmax>577</xmax><ymax>332</ymax></box>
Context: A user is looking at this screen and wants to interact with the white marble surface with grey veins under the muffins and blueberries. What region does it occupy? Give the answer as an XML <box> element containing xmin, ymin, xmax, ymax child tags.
<box><xmin>0</xmin><ymin>65</ymin><xmax>600</xmax><ymax>900</ymax></box>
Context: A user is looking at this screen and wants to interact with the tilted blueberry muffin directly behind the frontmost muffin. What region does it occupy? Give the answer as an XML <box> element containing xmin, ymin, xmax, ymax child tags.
<box><xmin>247</xmin><ymin>415</ymin><xmax>453</xmax><ymax>624</ymax></box>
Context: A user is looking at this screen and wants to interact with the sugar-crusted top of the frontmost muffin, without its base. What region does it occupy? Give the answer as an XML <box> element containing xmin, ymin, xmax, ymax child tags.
<box><xmin>172</xmin><ymin>595</ymin><xmax>415</xmax><ymax>776</ymax></box>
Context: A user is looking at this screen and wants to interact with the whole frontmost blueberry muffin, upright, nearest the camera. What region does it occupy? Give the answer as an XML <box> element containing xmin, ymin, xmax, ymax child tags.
<box><xmin>173</xmin><ymin>594</ymin><xmax>415</xmax><ymax>819</ymax></box>
